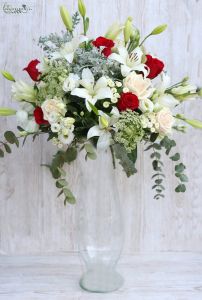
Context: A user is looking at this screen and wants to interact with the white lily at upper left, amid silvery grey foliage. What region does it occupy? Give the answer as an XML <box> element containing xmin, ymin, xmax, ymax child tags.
<box><xmin>52</xmin><ymin>35</ymin><xmax>88</xmax><ymax>64</ymax></box>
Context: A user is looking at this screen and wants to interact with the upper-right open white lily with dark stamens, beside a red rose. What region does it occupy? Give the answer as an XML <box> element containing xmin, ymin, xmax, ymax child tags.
<box><xmin>108</xmin><ymin>47</ymin><xmax>148</xmax><ymax>77</ymax></box>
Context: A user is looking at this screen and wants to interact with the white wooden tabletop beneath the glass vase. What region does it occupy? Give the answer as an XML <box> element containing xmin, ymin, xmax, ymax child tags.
<box><xmin>0</xmin><ymin>252</ymin><xmax>202</xmax><ymax>300</ymax></box>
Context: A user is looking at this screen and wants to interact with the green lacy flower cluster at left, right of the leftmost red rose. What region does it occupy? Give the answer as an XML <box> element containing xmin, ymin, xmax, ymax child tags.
<box><xmin>38</xmin><ymin>61</ymin><xmax>69</xmax><ymax>103</ymax></box>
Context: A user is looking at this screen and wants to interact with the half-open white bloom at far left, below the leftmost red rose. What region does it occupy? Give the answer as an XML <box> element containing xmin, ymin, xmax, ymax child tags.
<box><xmin>11</xmin><ymin>80</ymin><xmax>36</xmax><ymax>102</ymax></box>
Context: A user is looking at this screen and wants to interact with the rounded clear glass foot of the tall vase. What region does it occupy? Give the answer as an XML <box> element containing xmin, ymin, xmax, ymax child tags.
<box><xmin>80</xmin><ymin>269</ymin><xmax>124</xmax><ymax>293</ymax></box>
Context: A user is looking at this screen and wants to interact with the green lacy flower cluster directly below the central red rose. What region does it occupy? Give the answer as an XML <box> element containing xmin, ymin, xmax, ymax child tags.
<box><xmin>114</xmin><ymin>110</ymin><xmax>144</xmax><ymax>153</ymax></box>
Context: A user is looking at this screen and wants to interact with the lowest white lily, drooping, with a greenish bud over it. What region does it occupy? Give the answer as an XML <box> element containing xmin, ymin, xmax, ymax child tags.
<box><xmin>87</xmin><ymin>107</ymin><xmax>119</xmax><ymax>150</ymax></box>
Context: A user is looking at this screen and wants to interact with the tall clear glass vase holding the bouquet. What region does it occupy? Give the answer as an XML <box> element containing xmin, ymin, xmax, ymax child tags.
<box><xmin>77</xmin><ymin>154</ymin><xmax>124</xmax><ymax>293</ymax></box>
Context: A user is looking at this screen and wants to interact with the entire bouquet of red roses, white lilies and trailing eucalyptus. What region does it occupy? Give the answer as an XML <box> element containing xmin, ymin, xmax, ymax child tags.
<box><xmin>0</xmin><ymin>0</ymin><xmax>202</xmax><ymax>203</ymax></box>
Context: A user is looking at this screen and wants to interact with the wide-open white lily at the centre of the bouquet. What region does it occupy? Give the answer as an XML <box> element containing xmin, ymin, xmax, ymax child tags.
<box><xmin>71</xmin><ymin>68</ymin><xmax>113</xmax><ymax>111</ymax></box>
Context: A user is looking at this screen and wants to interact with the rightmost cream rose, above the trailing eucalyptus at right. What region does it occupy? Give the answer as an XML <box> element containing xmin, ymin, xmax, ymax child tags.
<box><xmin>156</xmin><ymin>107</ymin><xmax>174</xmax><ymax>134</ymax></box>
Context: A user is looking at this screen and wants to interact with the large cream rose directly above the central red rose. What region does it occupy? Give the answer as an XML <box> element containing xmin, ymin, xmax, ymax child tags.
<box><xmin>123</xmin><ymin>72</ymin><xmax>154</xmax><ymax>100</ymax></box>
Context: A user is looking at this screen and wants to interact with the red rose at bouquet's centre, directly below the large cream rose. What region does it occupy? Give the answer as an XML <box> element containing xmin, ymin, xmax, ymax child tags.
<box><xmin>117</xmin><ymin>93</ymin><xmax>139</xmax><ymax>111</ymax></box>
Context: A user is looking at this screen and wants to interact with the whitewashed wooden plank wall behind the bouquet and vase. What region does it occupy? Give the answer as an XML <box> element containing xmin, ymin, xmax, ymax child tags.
<box><xmin>0</xmin><ymin>0</ymin><xmax>202</xmax><ymax>254</ymax></box>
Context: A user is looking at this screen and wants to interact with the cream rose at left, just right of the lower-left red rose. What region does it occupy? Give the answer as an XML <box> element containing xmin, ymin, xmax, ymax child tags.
<box><xmin>41</xmin><ymin>99</ymin><xmax>66</xmax><ymax>124</ymax></box>
